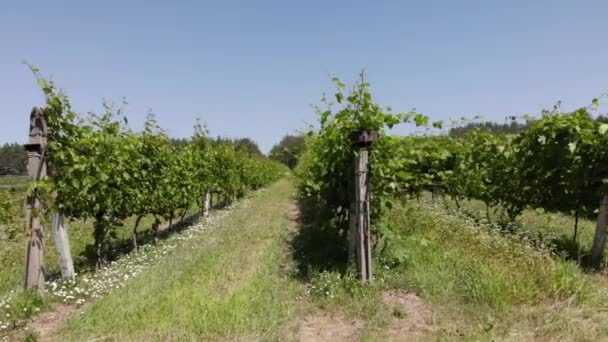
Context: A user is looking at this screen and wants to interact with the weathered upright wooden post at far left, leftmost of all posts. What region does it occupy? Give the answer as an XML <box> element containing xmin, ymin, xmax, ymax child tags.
<box><xmin>25</xmin><ymin>107</ymin><xmax>47</xmax><ymax>292</ymax></box>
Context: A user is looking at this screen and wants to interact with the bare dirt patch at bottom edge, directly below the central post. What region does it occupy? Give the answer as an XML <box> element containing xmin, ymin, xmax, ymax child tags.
<box><xmin>297</xmin><ymin>313</ymin><xmax>363</xmax><ymax>342</ymax></box>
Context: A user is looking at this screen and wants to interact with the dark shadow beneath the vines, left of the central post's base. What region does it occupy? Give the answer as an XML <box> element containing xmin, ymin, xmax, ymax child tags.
<box><xmin>291</xmin><ymin>200</ymin><xmax>348</xmax><ymax>281</ymax></box>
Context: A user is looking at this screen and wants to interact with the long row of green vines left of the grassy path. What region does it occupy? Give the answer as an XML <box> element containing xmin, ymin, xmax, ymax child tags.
<box><xmin>30</xmin><ymin>68</ymin><xmax>286</xmax><ymax>262</ymax></box>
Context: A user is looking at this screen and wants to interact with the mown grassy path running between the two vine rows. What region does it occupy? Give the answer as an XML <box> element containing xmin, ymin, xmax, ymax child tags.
<box><xmin>53</xmin><ymin>180</ymin><xmax>306</xmax><ymax>341</ymax></box>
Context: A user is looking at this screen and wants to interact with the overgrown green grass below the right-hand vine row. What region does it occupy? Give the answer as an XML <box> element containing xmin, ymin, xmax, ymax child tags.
<box><xmin>302</xmin><ymin>202</ymin><xmax>608</xmax><ymax>341</ymax></box>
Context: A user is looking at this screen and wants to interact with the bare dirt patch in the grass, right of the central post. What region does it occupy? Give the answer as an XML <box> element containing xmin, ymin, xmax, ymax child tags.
<box><xmin>382</xmin><ymin>290</ymin><xmax>433</xmax><ymax>341</ymax></box>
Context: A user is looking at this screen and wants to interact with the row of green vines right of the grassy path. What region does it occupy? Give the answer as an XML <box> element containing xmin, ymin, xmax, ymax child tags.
<box><xmin>297</xmin><ymin>75</ymin><xmax>608</xmax><ymax>266</ymax></box>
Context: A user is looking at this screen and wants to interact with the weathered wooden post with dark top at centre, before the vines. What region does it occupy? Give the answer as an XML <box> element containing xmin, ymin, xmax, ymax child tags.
<box><xmin>350</xmin><ymin>131</ymin><xmax>379</xmax><ymax>282</ymax></box>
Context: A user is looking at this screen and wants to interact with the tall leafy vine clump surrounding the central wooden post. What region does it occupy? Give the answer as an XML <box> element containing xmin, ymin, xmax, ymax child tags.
<box><xmin>296</xmin><ymin>73</ymin><xmax>428</xmax><ymax>256</ymax></box>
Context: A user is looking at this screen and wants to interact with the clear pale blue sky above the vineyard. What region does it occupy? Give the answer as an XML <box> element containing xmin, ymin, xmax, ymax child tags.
<box><xmin>0</xmin><ymin>0</ymin><xmax>608</xmax><ymax>152</ymax></box>
